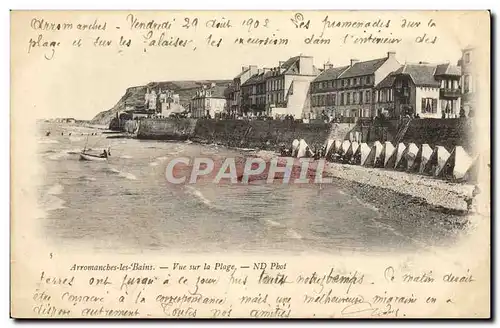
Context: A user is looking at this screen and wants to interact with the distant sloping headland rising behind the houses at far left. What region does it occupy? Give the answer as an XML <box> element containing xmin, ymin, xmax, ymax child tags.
<box><xmin>90</xmin><ymin>80</ymin><xmax>230</xmax><ymax>125</ymax></box>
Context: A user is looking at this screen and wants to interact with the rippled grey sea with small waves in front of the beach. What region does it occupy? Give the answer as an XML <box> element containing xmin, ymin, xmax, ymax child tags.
<box><xmin>37</xmin><ymin>122</ymin><xmax>464</xmax><ymax>254</ymax></box>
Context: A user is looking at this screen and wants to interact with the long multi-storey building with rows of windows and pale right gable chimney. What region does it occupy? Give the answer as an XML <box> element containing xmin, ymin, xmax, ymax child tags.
<box><xmin>310</xmin><ymin>52</ymin><xmax>401</xmax><ymax>117</ymax></box>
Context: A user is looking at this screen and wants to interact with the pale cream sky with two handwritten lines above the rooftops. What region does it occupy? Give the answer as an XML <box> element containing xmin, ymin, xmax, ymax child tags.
<box><xmin>11</xmin><ymin>11</ymin><xmax>489</xmax><ymax>119</ymax></box>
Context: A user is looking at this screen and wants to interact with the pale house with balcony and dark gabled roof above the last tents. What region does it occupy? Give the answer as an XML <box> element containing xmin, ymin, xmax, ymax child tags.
<box><xmin>392</xmin><ymin>63</ymin><xmax>461</xmax><ymax>118</ymax></box>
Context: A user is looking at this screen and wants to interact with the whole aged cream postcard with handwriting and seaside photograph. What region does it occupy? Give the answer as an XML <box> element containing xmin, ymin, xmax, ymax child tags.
<box><xmin>10</xmin><ymin>10</ymin><xmax>491</xmax><ymax>319</ymax></box>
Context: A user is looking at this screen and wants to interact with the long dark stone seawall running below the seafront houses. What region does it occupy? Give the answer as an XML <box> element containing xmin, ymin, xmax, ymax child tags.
<box><xmin>132</xmin><ymin>118</ymin><xmax>473</xmax><ymax>150</ymax></box>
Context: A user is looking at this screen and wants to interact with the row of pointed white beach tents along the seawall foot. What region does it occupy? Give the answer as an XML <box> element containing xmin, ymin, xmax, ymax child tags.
<box><xmin>290</xmin><ymin>139</ymin><xmax>479</xmax><ymax>182</ymax></box>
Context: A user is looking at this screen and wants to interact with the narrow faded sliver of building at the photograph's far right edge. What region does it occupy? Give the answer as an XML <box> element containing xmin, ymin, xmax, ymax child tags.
<box><xmin>458</xmin><ymin>46</ymin><xmax>478</xmax><ymax>116</ymax></box>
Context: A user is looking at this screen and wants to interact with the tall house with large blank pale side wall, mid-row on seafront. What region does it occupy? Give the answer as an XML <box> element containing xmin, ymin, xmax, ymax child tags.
<box><xmin>265</xmin><ymin>55</ymin><xmax>320</xmax><ymax>118</ymax></box>
